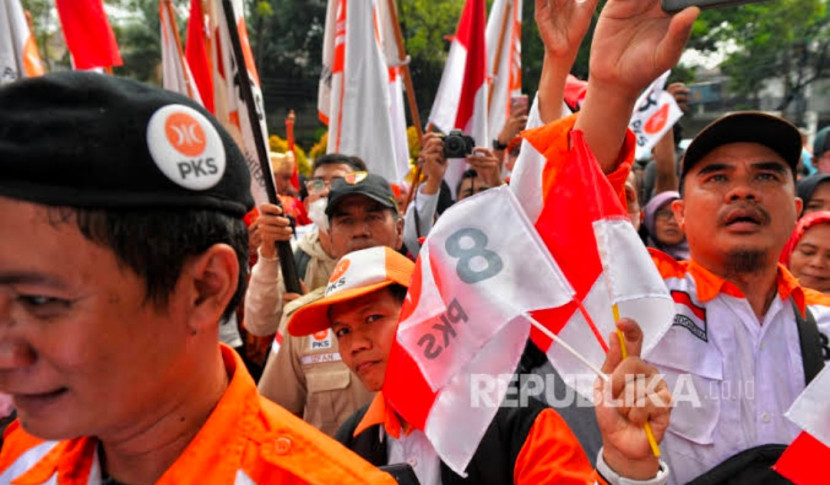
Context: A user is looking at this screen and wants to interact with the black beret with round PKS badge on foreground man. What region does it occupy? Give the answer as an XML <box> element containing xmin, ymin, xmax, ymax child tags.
<box><xmin>0</xmin><ymin>72</ymin><xmax>254</xmax><ymax>216</ymax></box>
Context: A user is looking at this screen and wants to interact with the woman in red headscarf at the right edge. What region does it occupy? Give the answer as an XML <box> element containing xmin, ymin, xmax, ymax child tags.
<box><xmin>781</xmin><ymin>211</ymin><xmax>830</xmax><ymax>294</ymax></box>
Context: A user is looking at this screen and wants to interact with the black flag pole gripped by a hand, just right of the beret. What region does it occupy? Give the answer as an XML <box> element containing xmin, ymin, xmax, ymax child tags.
<box><xmin>222</xmin><ymin>0</ymin><xmax>303</xmax><ymax>293</ymax></box>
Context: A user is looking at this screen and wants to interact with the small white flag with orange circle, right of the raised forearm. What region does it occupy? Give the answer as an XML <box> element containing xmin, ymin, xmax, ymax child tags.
<box><xmin>628</xmin><ymin>71</ymin><xmax>683</xmax><ymax>160</ymax></box>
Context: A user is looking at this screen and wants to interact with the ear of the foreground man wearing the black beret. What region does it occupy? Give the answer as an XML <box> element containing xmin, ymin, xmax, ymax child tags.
<box><xmin>185</xmin><ymin>244</ymin><xmax>239</xmax><ymax>334</ymax></box>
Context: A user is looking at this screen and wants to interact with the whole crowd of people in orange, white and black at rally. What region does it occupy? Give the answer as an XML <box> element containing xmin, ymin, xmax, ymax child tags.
<box><xmin>0</xmin><ymin>0</ymin><xmax>830</xmax><ymax>485</ymax></box>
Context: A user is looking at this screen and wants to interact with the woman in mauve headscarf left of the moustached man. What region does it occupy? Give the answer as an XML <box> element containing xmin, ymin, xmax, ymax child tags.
<box><xmin>643</xmin><ymin>190</ymin><xmax>689</xmax><ymax>261</ymax></box>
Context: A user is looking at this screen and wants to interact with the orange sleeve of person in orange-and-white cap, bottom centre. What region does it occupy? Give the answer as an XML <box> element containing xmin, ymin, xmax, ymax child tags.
<box><xmin>513</xmin><ymin>409</ymin><xmax>605</xmax><ymax>485</ymax></box>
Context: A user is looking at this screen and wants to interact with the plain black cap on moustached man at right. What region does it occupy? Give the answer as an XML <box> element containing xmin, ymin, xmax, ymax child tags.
<box><xmin>680</xmin><ymin>111</ymin><xmax>801</xmax><ymax>177</ymax></box>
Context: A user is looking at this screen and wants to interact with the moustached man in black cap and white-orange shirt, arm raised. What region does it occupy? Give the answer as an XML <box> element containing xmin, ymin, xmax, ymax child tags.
<box><xmin>540</xmin><ymin>0</ymin><xmax>830</xmax><ymax>483</ymax></box>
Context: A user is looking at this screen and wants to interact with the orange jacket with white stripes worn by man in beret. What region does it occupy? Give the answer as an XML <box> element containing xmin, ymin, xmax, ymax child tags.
<box><xmin>0</xmin><ymin>345</ymin><xmax>396</xmax><ymax>485</ymax></box>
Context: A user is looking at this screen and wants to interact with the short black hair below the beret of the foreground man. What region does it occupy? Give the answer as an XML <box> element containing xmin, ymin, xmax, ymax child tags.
<box><xmin>50</xmin><ymin>207</ymin><xmax>248</xmax><ymax>319</ymax></box>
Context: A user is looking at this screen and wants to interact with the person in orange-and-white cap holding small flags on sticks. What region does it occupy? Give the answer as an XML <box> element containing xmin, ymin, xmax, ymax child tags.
<box><xmin>288</xmin><ymin>247</ymin><xmax>670</xmax><ymax>485</ymax></box>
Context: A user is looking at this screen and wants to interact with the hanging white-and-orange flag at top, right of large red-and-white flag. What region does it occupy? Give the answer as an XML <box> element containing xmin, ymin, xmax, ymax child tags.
<box><xmin>485</xmin><ymin>0</ymin><xmax>522</xmax><ymax>140</ymax></box>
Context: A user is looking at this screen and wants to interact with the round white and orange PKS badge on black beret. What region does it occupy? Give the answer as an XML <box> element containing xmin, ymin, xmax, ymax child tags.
<box><xmin>147</xmin><ymin>104</ymin><xmax>226</xmax><ymax>190</ymax></box>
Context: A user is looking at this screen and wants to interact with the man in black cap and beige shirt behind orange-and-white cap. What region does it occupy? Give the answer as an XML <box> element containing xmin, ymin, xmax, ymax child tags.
<box><xmin>259</xmin><ymin>171</ymin><xmax>403</xmax><ymax>436</ymax></box>
